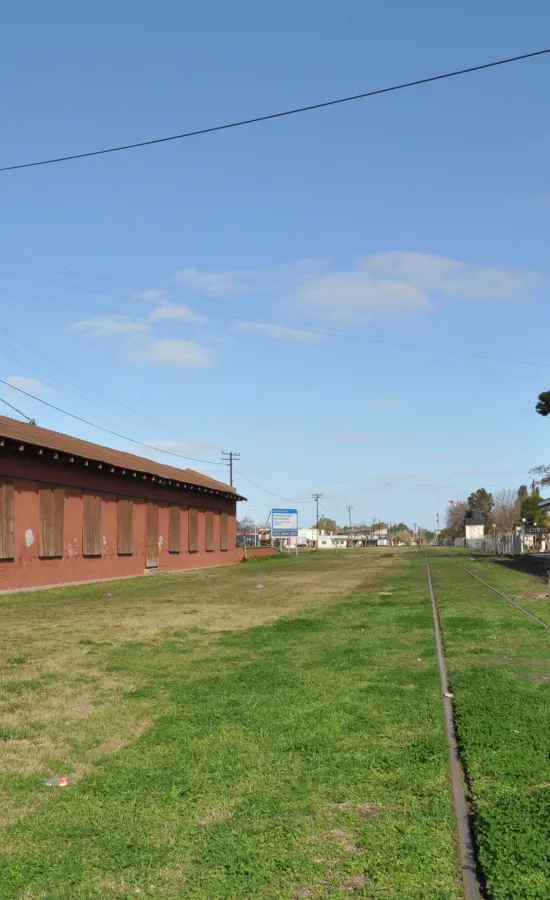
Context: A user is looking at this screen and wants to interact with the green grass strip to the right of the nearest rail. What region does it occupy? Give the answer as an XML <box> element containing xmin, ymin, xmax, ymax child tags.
<box><xmin>431</xmin><ymin>557</ymin><xmax>550</xmax><ymax>900</ymax></box>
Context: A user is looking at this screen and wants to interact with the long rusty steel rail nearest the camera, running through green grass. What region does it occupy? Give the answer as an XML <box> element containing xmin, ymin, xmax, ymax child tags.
<box><xmin>426</xmin><ymin>556</ymin><xmax>481</xmax><ymax>900</ymax></box>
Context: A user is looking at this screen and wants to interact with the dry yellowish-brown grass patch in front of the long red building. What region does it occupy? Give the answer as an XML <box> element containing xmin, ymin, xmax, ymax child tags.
<box><xmin>0</xmin><ymin>551</ymin><xmax>406</xmax><ymax>856</ymax></box>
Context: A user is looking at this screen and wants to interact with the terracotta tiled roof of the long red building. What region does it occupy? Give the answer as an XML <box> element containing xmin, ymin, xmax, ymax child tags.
<box><xmin>0</xmin><ymin>416</ymin><xmax>244</xmax><ymax>500</ymax></box>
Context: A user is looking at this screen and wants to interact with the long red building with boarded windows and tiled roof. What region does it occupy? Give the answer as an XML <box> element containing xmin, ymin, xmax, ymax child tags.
<box><xmin>0</xmin><ymin>416</ymin><xmax>244</xmax><ymax>591</ymax></box>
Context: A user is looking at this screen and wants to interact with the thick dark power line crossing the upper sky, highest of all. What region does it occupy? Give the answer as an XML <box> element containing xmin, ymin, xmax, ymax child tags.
<box><xmin>0</xmin><ymin>47</ymin><xmax>550</xmax><ymax>172</ymax></box>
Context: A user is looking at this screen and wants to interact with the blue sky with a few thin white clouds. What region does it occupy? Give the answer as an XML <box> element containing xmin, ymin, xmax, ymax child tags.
<box><xmin>0</xmin><ymin>0</ymin><xmax>550</xmax><ymax>527</ymax></box>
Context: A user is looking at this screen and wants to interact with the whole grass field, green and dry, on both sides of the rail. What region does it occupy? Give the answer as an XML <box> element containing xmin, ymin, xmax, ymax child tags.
<box><xmin>0</xmin><ymin>550</ymin><xmax>550</xmax><ymax>900</ymax></box>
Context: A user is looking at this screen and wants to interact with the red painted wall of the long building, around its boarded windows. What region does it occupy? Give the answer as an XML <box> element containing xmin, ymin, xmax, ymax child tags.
<box><xmin>0</xmin><ymin>456</ymin><xmax>242</xmax><ymax>591</ymax></box>
